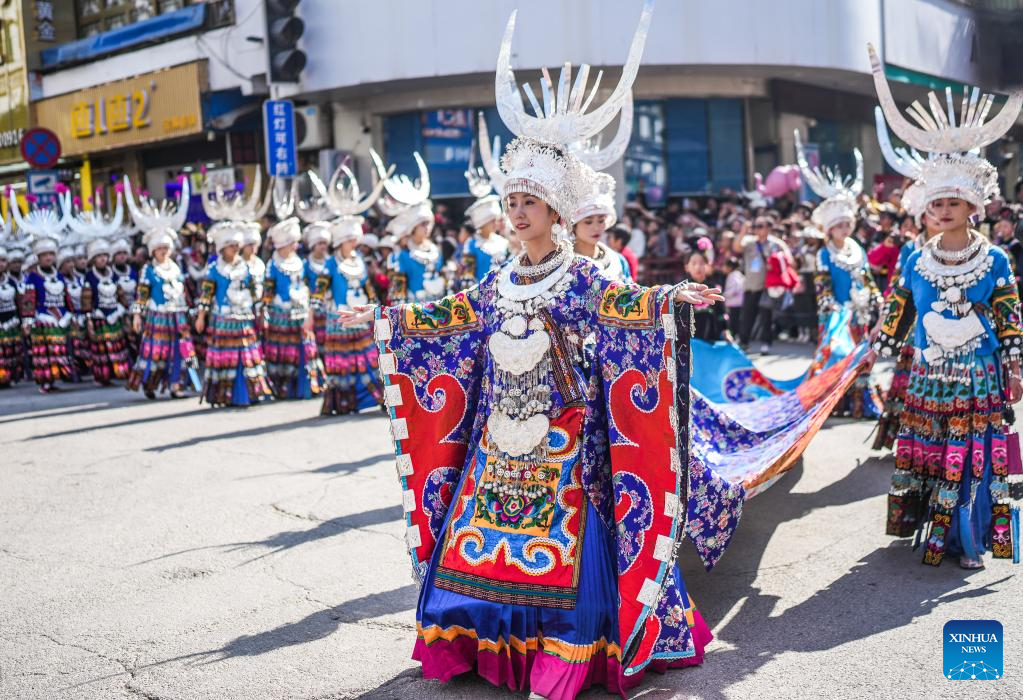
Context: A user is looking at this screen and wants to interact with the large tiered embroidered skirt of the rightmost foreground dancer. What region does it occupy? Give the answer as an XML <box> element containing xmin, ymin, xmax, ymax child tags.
<box><xmin>886</xmin><ymin>355</ymin><xmax>1012</xmax><ymax>566</ymax></box>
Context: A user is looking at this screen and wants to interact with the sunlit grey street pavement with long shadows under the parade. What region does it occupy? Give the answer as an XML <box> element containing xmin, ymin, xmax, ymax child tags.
<box><xmin>0</xmin><ymin>348</ymin><xmax>1023</xmax><ymax>700</ymax></box>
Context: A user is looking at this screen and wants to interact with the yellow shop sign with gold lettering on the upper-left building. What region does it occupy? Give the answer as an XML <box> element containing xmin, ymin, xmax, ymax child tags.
<box><xmin>36</xmin><ymin>61</ymin><xmax>206</xmax><ymax>156</ymax></box>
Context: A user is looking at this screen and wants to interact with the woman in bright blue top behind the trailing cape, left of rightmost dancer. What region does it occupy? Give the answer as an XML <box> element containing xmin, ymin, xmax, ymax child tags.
<box><xmin>814</xmin><ymin>215</ymin><xmax>882</xmax><ymax>419</ymax></box>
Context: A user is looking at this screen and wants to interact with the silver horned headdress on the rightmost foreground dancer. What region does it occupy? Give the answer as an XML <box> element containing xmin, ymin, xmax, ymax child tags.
<box><xmin>868</xmin><ymin>44</ymin><xmax>1023</xmax><ymax>208</ymax></box>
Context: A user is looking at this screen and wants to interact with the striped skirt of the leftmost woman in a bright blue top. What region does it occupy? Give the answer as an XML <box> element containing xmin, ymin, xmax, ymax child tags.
<box><xmin>127</xmin><ymin>309</ymin><xmax>198</xmax><ymax>393</ymax></box>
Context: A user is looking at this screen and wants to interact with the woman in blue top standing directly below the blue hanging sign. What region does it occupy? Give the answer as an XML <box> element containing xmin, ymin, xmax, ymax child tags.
<box><xmin>263</xmin><ymin>218</ymin><xmax>322</xmax><ymax>399</ymax></box>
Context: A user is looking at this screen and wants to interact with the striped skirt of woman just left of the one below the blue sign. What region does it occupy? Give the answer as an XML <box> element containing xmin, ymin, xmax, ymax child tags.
<box><xmin>199</xmin><ymin>310</ymin><xmax>273</xmax><ymax>406</ymax></box>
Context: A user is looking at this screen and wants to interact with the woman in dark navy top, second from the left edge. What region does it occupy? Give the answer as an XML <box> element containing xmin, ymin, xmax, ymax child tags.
<box><xmin>18</xmin><ymin>237</ymin><xmax>74</xmax><ymax>394</ymax></box>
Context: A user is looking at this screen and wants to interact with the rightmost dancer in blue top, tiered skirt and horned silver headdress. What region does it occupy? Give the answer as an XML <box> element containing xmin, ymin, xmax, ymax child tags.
<box><xmin>871</xmin><ymin>47</ymin><xmax>1023</xmax><ymax>569</ymax></box>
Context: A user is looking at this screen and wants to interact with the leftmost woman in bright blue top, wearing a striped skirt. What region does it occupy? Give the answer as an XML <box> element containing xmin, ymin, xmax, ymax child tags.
<box><xmin>126</xmin><ymin>228</ymin><xmax>202</xmax><ymax>399</ymax></box>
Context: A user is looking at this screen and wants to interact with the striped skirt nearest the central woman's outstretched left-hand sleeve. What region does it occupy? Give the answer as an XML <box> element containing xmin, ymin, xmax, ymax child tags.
<box><xmin>320</xmin><ymin>313</ymin><xmax>384</xmax><ymax>415</ymax></box>
